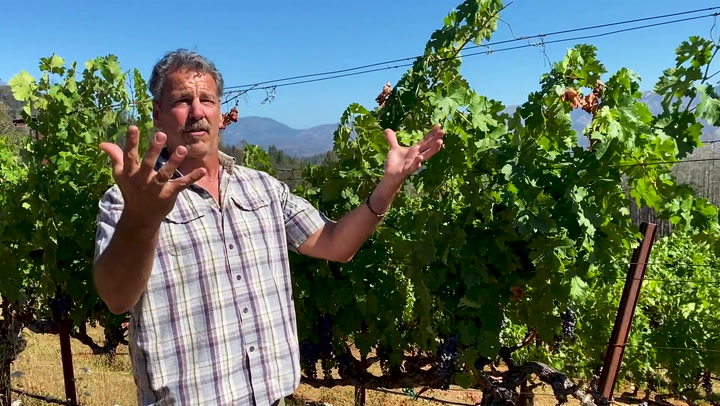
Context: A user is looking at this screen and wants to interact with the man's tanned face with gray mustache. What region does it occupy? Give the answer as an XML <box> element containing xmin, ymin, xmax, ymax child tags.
<box><xmin>153</xmin><ymin>71</ymin><xmax>222</xmax><ymax>159</ymax></box>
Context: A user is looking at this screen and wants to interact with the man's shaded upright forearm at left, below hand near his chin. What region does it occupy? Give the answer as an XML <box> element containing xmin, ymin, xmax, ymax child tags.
<box><xmin>93</xmin><ymin>216</ymin><xmax>160</xmax><ymax>314</ymax></box>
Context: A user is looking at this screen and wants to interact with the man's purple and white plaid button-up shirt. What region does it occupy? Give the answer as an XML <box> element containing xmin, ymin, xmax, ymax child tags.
<box><xmin>95</xmin><ymin>153</ymin><xmax>327</xmax><ymax>406</ymax></box>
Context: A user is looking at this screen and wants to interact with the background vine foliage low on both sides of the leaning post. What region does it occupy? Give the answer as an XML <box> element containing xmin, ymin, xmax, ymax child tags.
<box><xmin>504</xmin><ymin>232</ymin><xmax>720</xmax><ymax>400</ymax></box>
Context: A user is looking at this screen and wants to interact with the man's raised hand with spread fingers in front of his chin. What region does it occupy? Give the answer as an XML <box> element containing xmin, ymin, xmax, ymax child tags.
<box><xmin>100</xmin><ymin>126</ymin><xmax>207</xmax><ymax>221</ymax></box>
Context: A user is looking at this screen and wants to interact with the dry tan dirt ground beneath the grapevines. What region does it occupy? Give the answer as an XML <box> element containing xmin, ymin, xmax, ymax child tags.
<box><xmin>4</xmin><ymin>328</ymin><xmax>685</xmax><ymax>406</ymax></box>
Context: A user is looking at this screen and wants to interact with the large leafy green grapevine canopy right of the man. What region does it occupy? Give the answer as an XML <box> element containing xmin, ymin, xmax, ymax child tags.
<box><xmin>255</xmin><ymin>0</ymin><xmax>720</xmax><ymax>394</ymax></box>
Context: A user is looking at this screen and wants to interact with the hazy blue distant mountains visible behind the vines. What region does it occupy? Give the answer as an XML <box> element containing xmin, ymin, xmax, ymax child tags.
<box><xmin>222</xmin><ymin>92</ymin><xmax>720</xmax><ymax>157</ymax></box>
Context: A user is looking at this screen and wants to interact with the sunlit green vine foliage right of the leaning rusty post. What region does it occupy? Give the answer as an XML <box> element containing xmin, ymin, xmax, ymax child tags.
<box><xmin>624</xmin><ymin>233</ymin><xmax>720</xmax><ymax>391</ymax></box>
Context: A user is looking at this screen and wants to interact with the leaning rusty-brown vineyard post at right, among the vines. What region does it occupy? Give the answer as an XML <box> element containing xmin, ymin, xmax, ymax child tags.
<box><xmin>598</xmin><ymin>222</ymin><xmax>657</xmax><ymax>402</ymax></box>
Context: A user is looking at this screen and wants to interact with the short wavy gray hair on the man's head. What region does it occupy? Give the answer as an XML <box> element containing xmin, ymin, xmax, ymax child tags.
<box><xmin>148</xmin><ymin>49</ymin><xmax>224</xmax><ymax>100</ymax></box>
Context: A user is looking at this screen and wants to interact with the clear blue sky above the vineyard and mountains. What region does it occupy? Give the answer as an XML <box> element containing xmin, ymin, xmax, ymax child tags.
<box><xmin>0</xmin><ymin>0</ymin><xmax>720</xmax><ymax>128</ymax></box>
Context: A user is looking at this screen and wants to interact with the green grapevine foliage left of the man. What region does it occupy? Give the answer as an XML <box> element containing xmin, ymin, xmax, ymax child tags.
<box><xmin>0</xmin><ymin>55</ymin><xmax>151</xmax><ymax>334</ymax></box>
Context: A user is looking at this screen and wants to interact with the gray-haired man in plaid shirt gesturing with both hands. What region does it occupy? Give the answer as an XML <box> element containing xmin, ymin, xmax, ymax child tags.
<box><xmin>93</xmin><ymin>50</ymin><xmax>444</xmax><ymax>406</ymax></box>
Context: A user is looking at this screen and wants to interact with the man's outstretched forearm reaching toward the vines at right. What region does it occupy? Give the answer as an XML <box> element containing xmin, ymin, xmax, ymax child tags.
<box><xmin>309</xmin><ymin>179</ymin><xmax>402</xmax><ymax>262</ymax></box>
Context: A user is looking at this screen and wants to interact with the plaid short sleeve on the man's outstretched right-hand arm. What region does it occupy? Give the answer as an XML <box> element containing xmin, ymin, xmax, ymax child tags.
<box><xmin>278</xmin><ymin>181</ymin><xmax>330</xmax><ymax>252</ymax></box>
